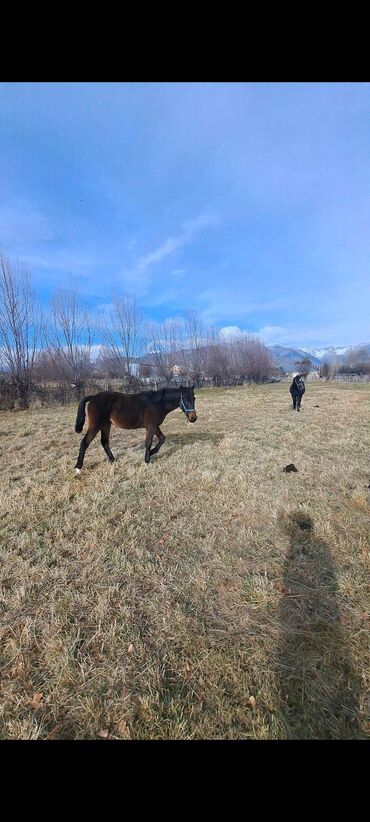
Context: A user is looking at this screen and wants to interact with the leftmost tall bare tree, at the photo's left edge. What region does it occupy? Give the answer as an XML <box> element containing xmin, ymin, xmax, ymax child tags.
<box><xmin>0</xmin><ymin>252</ymin><xmax>43</xmax><ymax>408</ymax></box>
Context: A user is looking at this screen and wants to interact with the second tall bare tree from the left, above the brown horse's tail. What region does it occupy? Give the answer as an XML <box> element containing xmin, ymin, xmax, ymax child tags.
<box><xmin>48</xmin><ymin>282</ymin><xmax>92</xmax><ymax>398</ymax></box>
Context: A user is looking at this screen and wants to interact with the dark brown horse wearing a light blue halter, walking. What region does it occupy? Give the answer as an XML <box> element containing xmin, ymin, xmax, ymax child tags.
<box><xmin>75</xmin><ymin>385</ymin><xmax>197</xmax><ymax>474</ymax></box>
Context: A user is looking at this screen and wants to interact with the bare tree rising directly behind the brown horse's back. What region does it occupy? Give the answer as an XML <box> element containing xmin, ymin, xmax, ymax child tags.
<box><xmin>101</xmin><ymin>294</ymin><xmax>144</xmax><ymax>385</ymax></box>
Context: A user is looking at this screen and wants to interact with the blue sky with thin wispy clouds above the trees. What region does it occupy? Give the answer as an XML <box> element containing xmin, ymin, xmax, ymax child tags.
<box><xmin>0</xmin><ymin>83</ymin><xmax>370</xmax><ymax>346</ymax></box>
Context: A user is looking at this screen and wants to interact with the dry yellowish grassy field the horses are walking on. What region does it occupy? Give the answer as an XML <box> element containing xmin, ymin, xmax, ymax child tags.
<box><xmin>0</xmin><ymin>383</ymin><xmax>370</xmax><ymax>739</ymax></box>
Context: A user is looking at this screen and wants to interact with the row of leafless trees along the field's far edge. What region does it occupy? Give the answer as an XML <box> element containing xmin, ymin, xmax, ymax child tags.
<box><xmin>0</xmin><ymin>249</ymin><xmax>274</xmax><ymax>408</ymax></box>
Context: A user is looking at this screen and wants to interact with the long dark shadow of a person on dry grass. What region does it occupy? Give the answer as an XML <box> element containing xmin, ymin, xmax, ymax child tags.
<box><xmin>276</xmin><ymin>511</ymin><xmax>365</xmax><ymax>739</ymax></box>
